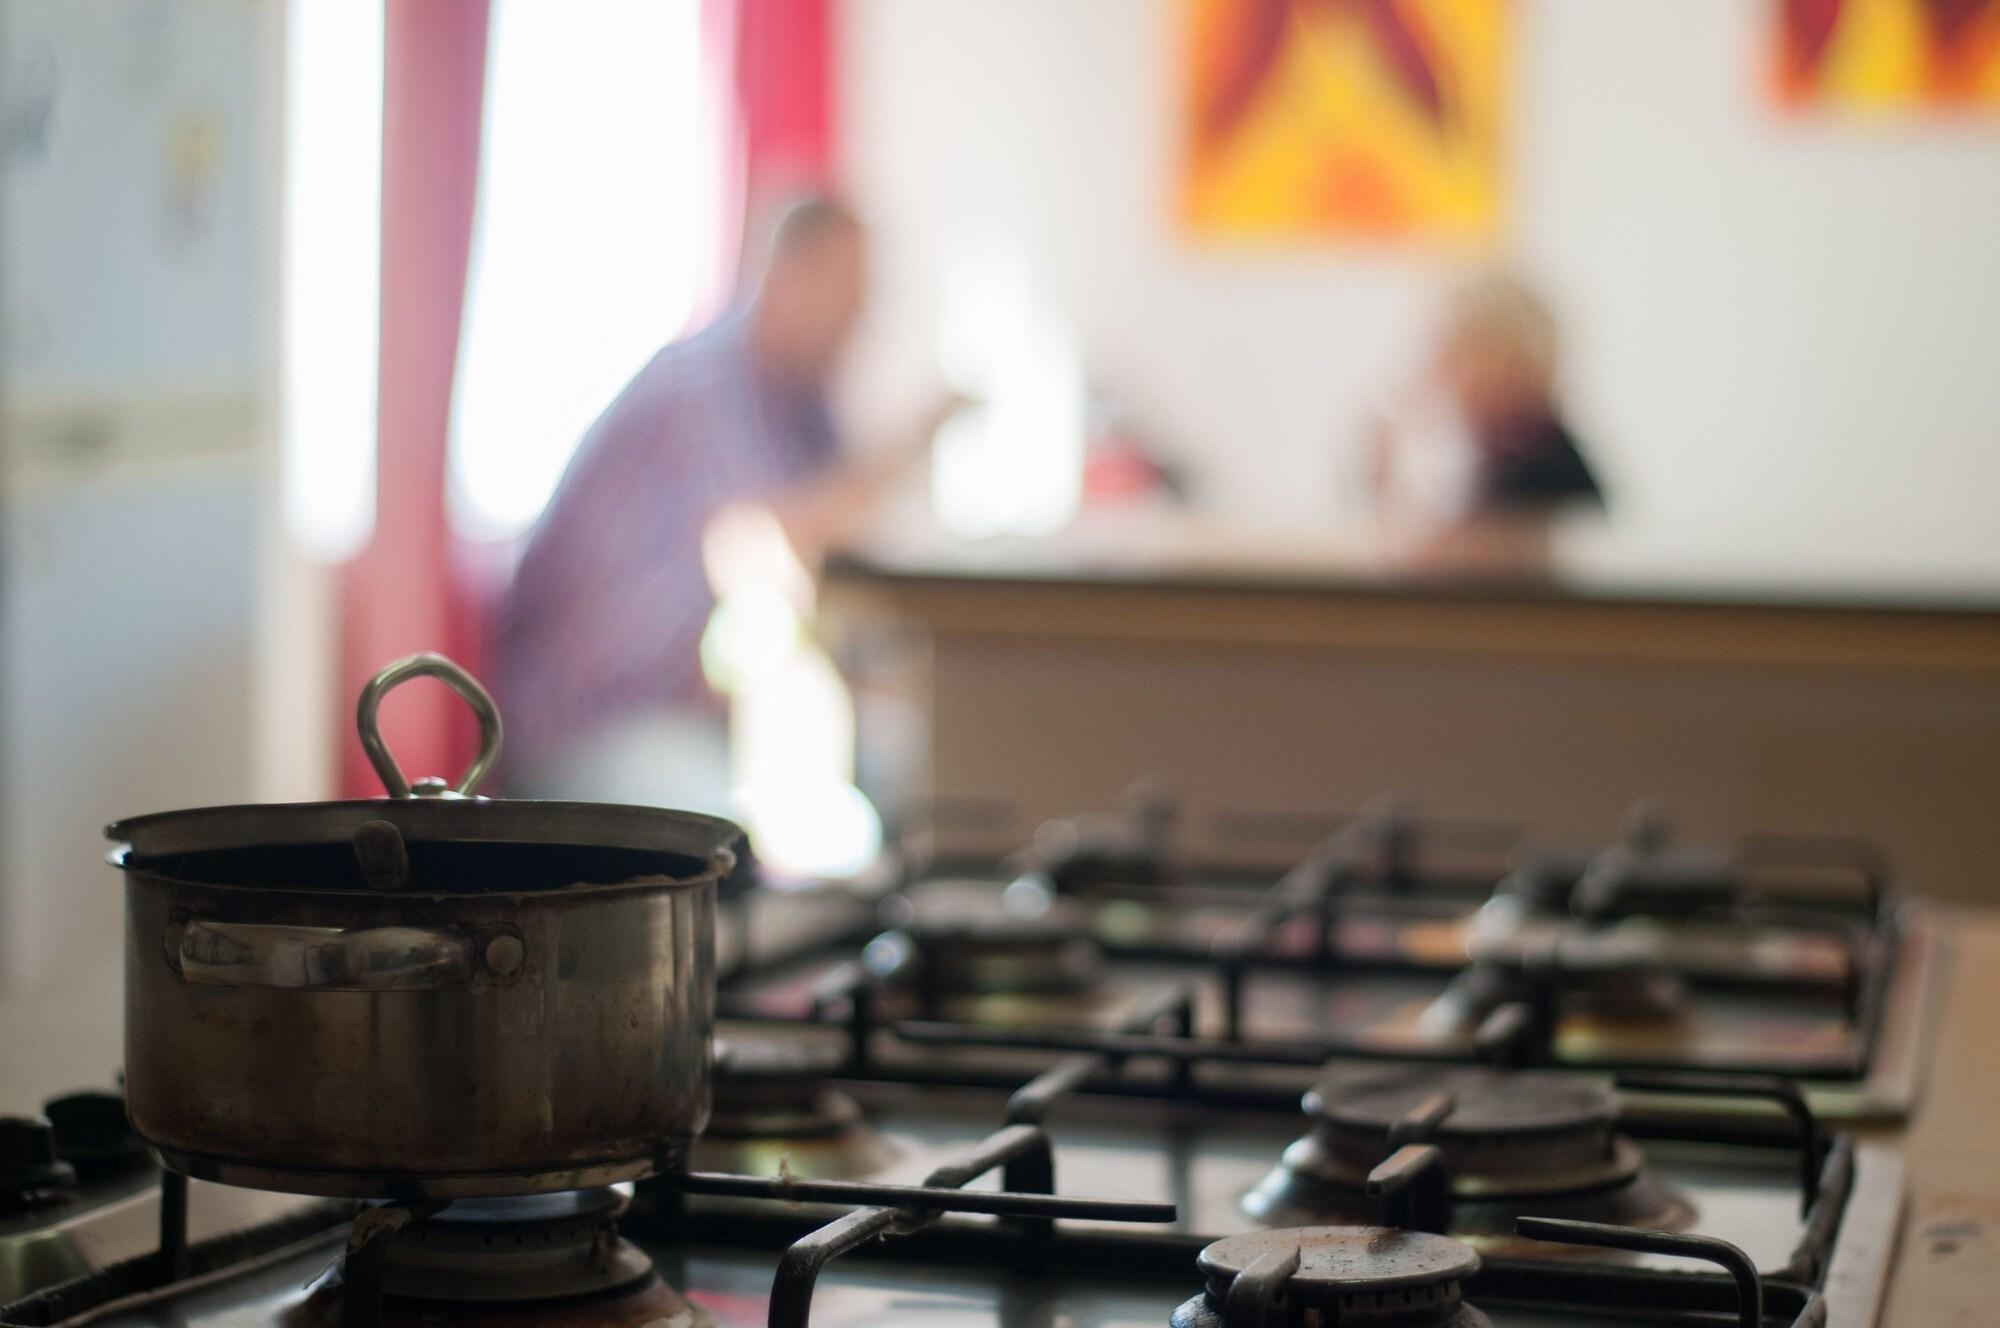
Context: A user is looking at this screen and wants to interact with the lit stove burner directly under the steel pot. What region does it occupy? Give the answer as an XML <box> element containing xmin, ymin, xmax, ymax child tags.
<box><xmin>284</xmin><ymin>1188</ymin><xmax>714</xmax><ymax>1328</ymax></box>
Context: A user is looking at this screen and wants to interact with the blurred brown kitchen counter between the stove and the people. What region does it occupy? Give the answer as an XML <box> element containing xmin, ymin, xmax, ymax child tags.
<box><xmin>822</xmin><ymin>514</ymin><xmax>2000</xmax><ymax>900</ymax></box>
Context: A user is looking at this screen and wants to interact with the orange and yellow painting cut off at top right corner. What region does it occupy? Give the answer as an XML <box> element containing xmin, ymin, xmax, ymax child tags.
<box><xmin>1770</xmin><ymin>0</ymin><xmax>2000</xmax><ymax>112</ymax></box>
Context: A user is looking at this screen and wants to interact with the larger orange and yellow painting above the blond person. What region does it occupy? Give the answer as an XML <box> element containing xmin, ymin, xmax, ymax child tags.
<box><xmin>1180</xmin><ymin>0</ymin><xmax>1508</xmax><ymax>244</ymax></box>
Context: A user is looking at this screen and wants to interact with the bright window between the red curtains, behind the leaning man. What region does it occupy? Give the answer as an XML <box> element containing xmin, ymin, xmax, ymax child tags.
<box><xmin>450</xmin><ymin>0</ymin><xmax>722</xmax><ymax>538</ymax></box>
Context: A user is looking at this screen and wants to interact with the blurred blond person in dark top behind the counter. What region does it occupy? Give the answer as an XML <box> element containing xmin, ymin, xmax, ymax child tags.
<box><xmin>1372</xmin><ymin>272</ymin><xmax>1604</xmax><ymax>570</ymax></box>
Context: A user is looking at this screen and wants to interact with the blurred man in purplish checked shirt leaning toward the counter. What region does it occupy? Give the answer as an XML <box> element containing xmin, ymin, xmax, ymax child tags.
<box><xmin>498</xmin><ymin>198</ymin><xmax>900</xmax><ymax>810</ymax></box>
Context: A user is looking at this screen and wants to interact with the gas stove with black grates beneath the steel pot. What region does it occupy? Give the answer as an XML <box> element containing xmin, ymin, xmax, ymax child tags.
<box><xmin>0</xmin><ymin>804</ymin><xmax>1940</xmax><ymax>1328</ymax></box>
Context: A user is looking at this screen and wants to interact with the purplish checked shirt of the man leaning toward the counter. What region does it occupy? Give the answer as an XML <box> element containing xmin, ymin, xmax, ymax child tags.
<box><xmin>508</xmin><ymin>314</ymin><xmax>836</xmax><ymax>770</ymax></box>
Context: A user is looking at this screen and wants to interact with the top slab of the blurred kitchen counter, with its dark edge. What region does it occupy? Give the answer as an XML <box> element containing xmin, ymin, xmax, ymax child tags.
<box><xmin>826</xmin><ymin>512</ymin><xmax>2000</xmax><ymax>672</ymax></box>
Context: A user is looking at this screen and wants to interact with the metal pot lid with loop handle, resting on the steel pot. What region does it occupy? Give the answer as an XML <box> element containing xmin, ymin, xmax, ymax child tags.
<box><xmin>104</xmin><ymin>654</ymin><xmax>742</xmax><ymax>890</ymax></box>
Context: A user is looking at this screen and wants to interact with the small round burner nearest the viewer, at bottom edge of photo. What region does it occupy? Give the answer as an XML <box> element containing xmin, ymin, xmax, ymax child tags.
<box><xmin>1172</xmin><ymin>1226</ymin><xmax>1492</xmax><ymax>1328</ymax></box>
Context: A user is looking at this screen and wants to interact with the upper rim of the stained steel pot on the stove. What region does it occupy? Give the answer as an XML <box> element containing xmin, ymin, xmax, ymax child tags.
<box><xmin>104</xmin><ymin>798</ymin><xmax>742</xmax><ymax>898</ymax></box>
